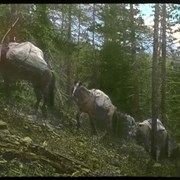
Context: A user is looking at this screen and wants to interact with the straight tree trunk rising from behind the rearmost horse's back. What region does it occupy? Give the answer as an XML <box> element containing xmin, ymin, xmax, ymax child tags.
<box><xmin>161</xmin><ymin>4</ymin><xmax>166</xmax><ymax>124</ymax></box>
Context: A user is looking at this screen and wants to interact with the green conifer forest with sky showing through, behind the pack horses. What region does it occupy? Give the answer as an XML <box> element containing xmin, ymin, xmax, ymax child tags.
<box><xmin>0</xmin><ymin>4</ymin><xmax>180</xmax><ymax>176</ymax></box>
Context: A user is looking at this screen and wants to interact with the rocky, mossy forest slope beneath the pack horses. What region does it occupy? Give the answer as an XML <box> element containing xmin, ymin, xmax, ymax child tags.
<box><xmin>0</xmin><ymin>101</ymin><xmax>180</xmax><ymax>177</ymax></box>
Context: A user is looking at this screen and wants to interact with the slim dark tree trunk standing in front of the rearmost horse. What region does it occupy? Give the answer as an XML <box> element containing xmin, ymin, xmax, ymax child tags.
<box><xmin>151</xmin><ymin>4</ymin><xmax>159</xmax><ymax>159</ymax></box>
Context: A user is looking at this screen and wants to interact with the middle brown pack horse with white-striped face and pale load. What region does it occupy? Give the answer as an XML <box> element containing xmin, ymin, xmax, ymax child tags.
<box><xmin>72</xmin><ymin>82</ymin><xmax>124</xmax><ymax>135</ymax></box>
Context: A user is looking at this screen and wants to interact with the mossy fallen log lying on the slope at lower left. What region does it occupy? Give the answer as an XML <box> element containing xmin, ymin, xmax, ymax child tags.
<box><xmin>0</xmin><ymin>139</ymin><xmax>90</xmax><ymax>174</ymax></box>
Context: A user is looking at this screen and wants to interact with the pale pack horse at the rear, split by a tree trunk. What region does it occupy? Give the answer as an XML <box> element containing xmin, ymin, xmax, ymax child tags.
<box><xmin>134</xmin><ymin>119</ymin><xmax>168</xmax><ymax>160</ymax></box>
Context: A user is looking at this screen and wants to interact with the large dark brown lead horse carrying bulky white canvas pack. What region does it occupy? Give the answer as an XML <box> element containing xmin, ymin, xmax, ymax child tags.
<box><xmin>0</xmin><ymin>42</ymin><xmax>55</xmax><ymax>115</ymax></box>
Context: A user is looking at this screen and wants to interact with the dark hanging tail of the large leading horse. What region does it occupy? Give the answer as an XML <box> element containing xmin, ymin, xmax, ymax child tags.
<box><xmin>48</xmin><ymin>71</ymin><xmax>56</xmax><ymax>107</ymax></box>
